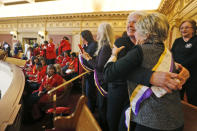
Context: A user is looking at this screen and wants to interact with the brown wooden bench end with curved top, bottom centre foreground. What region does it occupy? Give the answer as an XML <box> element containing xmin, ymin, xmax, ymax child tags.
<box><xmin>54</xmin><ymin>95</ymin><xmax>101</xmax><ymax>131</ymax></box>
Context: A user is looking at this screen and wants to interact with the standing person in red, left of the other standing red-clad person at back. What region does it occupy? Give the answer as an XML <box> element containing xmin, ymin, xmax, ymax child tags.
<box><xmin>46</xmin><ymin>38</ymin><xmax>56</xmax><ymax>65</ymax></box>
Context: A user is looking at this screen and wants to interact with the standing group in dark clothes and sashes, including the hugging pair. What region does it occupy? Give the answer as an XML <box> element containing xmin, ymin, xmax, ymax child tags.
<box><xmin>81</xmin><ymin>12</ymin><xmax>192</xmax><ymax>131</ymax></box>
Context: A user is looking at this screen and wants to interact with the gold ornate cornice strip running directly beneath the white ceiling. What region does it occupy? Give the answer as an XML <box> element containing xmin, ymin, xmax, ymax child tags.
<box><xmin>0</xmin><ymin>11</ymin><xmax>132</xmax><ymax>24</ymax></box>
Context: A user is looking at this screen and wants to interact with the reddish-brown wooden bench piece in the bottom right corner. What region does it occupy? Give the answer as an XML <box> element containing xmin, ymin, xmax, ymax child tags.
<box><xmin>182</xmin><ymin>101</ymin><xmax>197</xmax><ymax>131</ymax></box>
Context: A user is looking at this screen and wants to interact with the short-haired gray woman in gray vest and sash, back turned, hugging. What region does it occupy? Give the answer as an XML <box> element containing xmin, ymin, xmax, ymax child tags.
<box><xmin>105</xmin><ymin>13</ymin><xmax>183</xmax><ymax>131</ymax></box>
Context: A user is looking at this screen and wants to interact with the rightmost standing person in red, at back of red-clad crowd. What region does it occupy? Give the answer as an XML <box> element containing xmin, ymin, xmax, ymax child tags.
<box><xmin>58</xmin><ymin>36</ymin><xmax>71</xmax><ymax>55</ymax></box>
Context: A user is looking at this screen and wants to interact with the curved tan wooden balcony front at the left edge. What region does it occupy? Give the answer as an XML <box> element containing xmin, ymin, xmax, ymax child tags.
<box><xmin>0</xmin><ymin>61</ymin><xmax>25</xmax><ymax>131</ymax></box>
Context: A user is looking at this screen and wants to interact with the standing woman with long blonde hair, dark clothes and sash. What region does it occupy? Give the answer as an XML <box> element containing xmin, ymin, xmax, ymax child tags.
<box><xmin>83</xmin><ymin>23</ymin><xmax>114</xmax><ymax>131</ymax></box>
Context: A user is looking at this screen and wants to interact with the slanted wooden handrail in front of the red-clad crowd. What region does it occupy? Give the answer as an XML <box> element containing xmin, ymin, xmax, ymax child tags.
<box><xmin>47</xmin><ymin>71</ymin><xmax>90</xmax><ymax>94</ymax></box>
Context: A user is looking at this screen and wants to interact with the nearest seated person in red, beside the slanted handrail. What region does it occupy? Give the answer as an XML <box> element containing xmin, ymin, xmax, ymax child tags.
<box><xmin>24</xmin><ymin>64</ymin><xmax>64</xmax><ymax>120</ymax></box>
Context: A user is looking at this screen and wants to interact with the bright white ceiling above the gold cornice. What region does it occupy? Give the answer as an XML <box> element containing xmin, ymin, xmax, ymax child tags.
<box><xmin>0</xmin><ymin>0</ymin><xmax>163</xmax><ymax>18</ymax></box>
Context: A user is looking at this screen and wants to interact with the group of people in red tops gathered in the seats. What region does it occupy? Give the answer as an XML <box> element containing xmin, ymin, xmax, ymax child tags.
<box><xmin>17</xmin><ymin>36</ymin><xmax>79</xmax><ymax>123</ymax></box>
